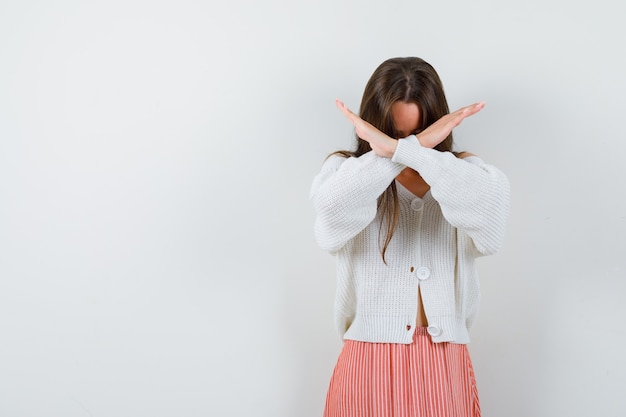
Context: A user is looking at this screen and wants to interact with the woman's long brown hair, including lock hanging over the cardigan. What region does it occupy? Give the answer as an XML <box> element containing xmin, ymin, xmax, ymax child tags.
<box><xmin>333</xmin><ymin>57</ymin><xmax>452</xmax><ymax>263</ymax></box>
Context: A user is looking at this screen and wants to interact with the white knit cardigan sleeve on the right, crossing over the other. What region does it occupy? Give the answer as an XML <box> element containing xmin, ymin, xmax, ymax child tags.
<box><xmin>391</xmin><ymin>136</ymin><xmax>510</xmax><ymax>255</ymax></box>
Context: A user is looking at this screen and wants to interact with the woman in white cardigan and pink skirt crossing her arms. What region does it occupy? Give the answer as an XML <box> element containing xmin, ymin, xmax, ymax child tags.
<box><xmin>311</xmin><ymin>58</ymin><xmax>509</xmax><ymax>417</ymax></box>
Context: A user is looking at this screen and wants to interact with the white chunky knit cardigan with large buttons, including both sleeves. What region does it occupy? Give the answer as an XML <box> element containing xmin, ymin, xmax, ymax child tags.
<box><xmin>310</xmin><ymin>136</ymin><xmax>510</xmax><ymax>344</ymax></box>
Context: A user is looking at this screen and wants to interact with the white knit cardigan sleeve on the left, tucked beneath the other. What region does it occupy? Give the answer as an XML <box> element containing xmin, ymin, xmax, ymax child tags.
<box><xmin>310</xmin><ymin>151</ymin><xmax>405</xmax><ymax>253</ymax></box>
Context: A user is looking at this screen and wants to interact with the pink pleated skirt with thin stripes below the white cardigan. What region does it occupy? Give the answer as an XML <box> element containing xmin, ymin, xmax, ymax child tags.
<box><xmin>324</xmin><ymin>327</ymin><xmax>480</xmax><ymax>417</ymax></box>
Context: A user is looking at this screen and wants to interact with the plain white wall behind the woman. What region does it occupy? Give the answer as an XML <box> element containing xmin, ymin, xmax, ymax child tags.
<box><xmin>0</xmin><ymin>0</ymin><xmax>626</xmax><ymax>417</ymax></box>
